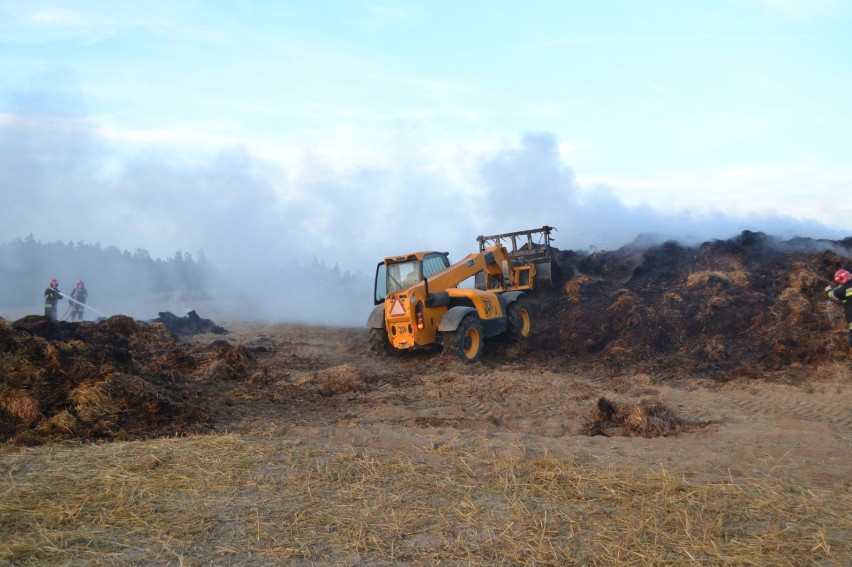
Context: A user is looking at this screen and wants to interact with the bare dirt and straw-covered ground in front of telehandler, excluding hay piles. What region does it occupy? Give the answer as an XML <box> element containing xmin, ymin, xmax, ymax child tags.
<box><xmin>0</xmin><ymin>323</ymin><xmax>852</xmax><ymax>565</ymax></box>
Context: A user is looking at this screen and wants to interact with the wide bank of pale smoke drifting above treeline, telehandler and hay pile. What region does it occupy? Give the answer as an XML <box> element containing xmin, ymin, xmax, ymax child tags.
<box><xmin>0</xmin><ymin>80</ymin><xmax>847</xmax><ymax>324</ymax></box>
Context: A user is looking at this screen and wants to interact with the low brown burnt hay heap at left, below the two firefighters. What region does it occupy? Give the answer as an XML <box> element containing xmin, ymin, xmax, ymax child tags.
<box><xmin>0</xmin><ymin>316</ymin><xmax>256</xmax><ymax>444</ymax></box>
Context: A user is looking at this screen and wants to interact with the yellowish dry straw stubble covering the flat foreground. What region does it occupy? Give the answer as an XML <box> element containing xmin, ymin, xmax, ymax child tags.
<box><xmin>0</xmin><ymin>435</ymin><xmax>852</xmax><ymax>566</ymax></box>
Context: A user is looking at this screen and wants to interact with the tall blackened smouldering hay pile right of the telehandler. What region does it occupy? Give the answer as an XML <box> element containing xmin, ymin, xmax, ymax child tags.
<box><xmin>531</xmin><ymin>231</ymin><xmax>852</xmax><ymax>380</ymax></box>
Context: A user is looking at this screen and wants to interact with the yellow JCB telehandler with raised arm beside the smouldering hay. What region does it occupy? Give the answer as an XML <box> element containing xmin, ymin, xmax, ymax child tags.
<box><xmin>367</xmin><ymin>227</ymin><xmax>550</xmax><ymax>362</ymax></box>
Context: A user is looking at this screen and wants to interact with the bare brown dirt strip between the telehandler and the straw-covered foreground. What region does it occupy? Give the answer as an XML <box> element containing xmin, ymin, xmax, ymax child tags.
<box><xmin>178</xmin><ymin>323</ymin><xmax>852</xmax><ymax>490</ymax></box>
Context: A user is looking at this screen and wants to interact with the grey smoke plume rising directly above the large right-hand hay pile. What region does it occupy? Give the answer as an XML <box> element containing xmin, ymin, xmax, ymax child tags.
<box><xmin>481</xmin><ymin>133</ymin><xmax>848</xmax><ymax>249</ymax></box>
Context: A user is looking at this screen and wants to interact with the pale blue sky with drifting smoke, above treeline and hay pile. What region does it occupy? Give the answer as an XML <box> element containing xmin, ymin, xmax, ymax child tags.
<box><xmin>0</xmin><ymin>0</ymin><xmax>852</xmax><ymax>271</ymax></box>
